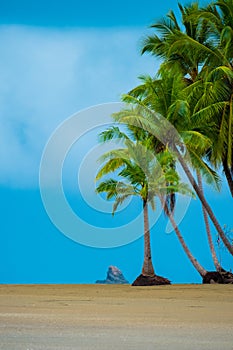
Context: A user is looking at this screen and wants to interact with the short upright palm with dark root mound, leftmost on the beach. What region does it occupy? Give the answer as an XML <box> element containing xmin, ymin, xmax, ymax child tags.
<box><xmin>96</xmin><ymin>141</ymin><xmax>170</xmax><ymax>285</ymax></box>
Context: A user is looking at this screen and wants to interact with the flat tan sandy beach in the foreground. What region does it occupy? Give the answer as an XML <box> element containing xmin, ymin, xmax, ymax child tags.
<box><xmin>0</xmin><ymin>285</ymin><xmax>233</xmax><ymax>350</ymax></box>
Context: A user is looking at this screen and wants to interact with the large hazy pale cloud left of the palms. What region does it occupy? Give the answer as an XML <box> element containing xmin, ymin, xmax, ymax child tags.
<box><xmin>0</xmin><ymin>26</ymin><xmax>158</xmax><ymax>187</ymax></box>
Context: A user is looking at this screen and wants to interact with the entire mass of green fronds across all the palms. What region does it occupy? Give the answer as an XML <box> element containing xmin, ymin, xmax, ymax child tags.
<box><xmin>96</xmin><ymin>0</ymin><xmax>233</xmax><ymax>219</ymax></box>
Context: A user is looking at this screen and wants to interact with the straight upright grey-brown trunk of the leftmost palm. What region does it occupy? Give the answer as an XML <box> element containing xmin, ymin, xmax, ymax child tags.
<box><xmin>142</xmin><ymin>200</ymin><xmax>155</xmax><ymax>276</ymax></box>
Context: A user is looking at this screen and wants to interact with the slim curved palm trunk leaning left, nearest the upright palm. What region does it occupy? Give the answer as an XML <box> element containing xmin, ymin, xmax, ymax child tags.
<box><xmin>161</xmin><ymin>199</ymin><xmax>207</xmax><ymax>277</ymax></box>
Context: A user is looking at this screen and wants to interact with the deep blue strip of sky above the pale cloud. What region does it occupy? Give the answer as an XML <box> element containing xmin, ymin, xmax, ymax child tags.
<box><xmin>0</xmin><ymin>0</ymin><xmax>186</xmax><ymax>28</ymax></box>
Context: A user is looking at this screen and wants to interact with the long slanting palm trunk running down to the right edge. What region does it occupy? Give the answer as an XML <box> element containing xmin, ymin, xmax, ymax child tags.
<box><xmin>174</xmin><ymin>147</ymin><xmax>233</xmax><ymax>255</ymax></box>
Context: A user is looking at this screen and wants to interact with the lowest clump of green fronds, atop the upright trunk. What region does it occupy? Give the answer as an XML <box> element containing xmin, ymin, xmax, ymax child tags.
<box><xmin>96</xmin><ymin>131</ymin><xmax>192</xmax><ymax>214</ymax></box>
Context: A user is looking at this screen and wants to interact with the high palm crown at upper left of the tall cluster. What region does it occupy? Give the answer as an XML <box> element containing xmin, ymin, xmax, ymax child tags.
<box><xmin>141</xmin><ymin>3</ymin><xmax>212</xmax><ymax>84</ymax></box>
